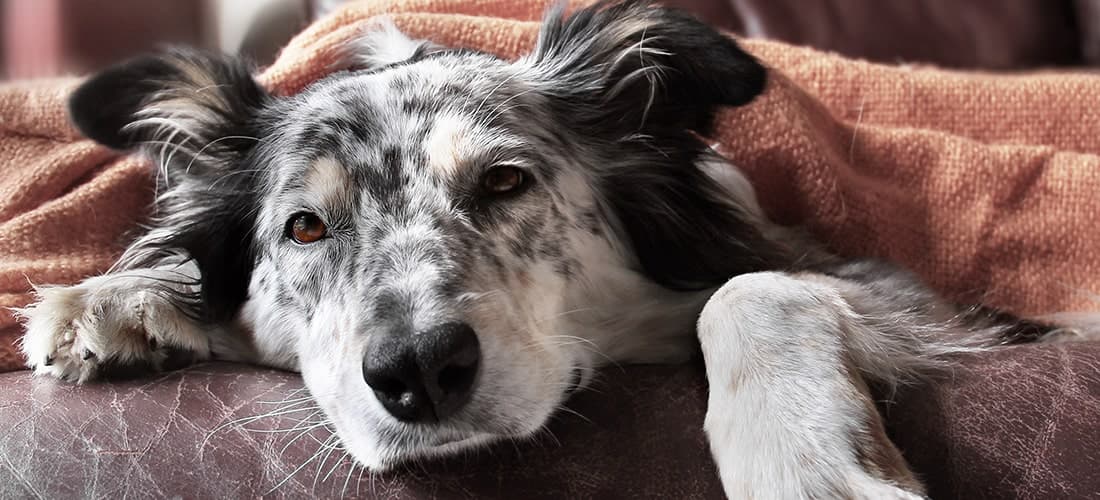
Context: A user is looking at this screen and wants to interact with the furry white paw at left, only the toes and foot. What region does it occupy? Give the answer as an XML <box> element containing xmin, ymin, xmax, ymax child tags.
<box><xmin>18</xmin><ymin>278</ymin><xmax>208</xmax><ymax>382</ymax></box>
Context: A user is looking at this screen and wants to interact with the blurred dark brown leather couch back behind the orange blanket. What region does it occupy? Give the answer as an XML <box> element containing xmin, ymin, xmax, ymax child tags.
<box><xmin>666</xmin><ymin>0</ymin><xmax>1100</xmax><ymax>69</ymax></box>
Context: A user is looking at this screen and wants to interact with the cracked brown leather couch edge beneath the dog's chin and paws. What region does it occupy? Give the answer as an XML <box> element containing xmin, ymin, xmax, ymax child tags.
<box><xmin>0</xmin><ymin>344</ymin><xmax>1100</xmax><ymax>499</ymax></box>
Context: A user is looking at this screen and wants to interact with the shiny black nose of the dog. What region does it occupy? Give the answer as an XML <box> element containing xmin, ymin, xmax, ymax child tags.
<box><xmin>363</xmin><ymin>323</ymin><xmax>481</xmax><ymax>422</ymax></box>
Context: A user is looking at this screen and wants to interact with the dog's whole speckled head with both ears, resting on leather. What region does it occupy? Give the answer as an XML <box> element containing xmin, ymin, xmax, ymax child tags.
<box><xmin>70</xmin><ymin>2</ymin><xmax>777</xmax><ymax>467</ymax></box>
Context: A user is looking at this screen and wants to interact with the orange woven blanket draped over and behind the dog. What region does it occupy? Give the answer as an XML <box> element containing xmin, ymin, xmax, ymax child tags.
<box><xmin>0</xmin><ymin>0</ymin><xmax>1100</xmax><ymax>378</ymax></box>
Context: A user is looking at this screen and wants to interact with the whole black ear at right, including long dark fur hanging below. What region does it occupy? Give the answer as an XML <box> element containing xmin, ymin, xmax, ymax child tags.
<box><xmin>519</xmin><ymin>0</ymin><xmax>785</xmax><ymax>290</ymax></box>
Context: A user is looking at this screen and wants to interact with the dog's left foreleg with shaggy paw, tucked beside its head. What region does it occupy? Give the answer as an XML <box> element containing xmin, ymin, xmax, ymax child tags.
<box><xmin>19</xmin><ymin>263</ymin><xmax>250</xmax><ymax>381</ymax></box>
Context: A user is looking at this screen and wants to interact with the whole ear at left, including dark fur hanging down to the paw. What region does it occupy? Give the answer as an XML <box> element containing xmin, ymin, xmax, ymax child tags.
<box><xmin>69</xmin><ymin>49</ymin><xmax>270</xmax><ymax>320</ymax></box>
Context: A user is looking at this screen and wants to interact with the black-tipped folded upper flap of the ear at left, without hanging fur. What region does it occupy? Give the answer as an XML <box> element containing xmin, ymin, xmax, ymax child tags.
<box><xmin>68</xmin><ymin>49</ymin><xmax>270</xmax><ymax>175</ymax></box>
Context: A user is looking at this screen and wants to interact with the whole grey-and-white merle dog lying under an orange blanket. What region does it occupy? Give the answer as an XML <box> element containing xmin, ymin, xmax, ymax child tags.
<box><xmin>21</xmin><ymin>0</ymin><xmax>1085</xmax><ymax>499</ymax></box>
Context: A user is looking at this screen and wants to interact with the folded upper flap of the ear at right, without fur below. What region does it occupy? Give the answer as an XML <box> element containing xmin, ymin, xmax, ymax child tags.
<box><xmin>526</xmin><ymin>0</ymin><xmax>767</xmax><ymax>135</ymax></box>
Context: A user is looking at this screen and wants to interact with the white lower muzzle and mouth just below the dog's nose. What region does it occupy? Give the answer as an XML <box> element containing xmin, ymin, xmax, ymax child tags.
<box><xmin>303</xmin><ymin>342</ymin><xmax>593</xmax><ymax>471</ymax></box>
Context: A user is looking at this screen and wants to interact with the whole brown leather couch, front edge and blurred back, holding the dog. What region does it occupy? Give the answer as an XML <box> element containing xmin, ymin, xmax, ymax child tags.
<box><xmin>0</xmin><ymin>0</ymin><xmax>1100</xmax><ymax>499</ymax></box>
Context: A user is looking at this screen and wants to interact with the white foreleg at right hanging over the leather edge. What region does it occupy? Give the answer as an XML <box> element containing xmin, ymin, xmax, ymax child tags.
<box><xmin>699</xmin><ymin>273</ymin><xmax>923</xmax><ymax>499</ymax></box>
